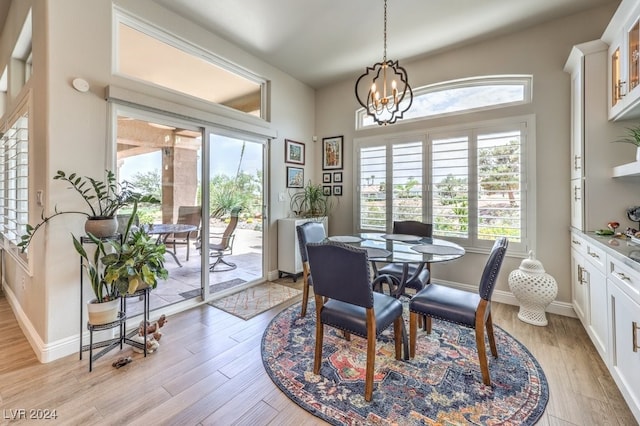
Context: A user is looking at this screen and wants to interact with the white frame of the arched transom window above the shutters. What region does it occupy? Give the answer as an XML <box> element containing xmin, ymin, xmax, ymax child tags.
<box><xmin>356</xmin><ymin>75</ymin><xmax>533</xmax><ymax>130</ymax></box>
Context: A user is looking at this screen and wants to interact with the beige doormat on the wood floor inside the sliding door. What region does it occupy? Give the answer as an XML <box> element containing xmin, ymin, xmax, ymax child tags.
<box><xmin>209</xmin><ymin>282</ymin><xmax>302</xmax><ymax>320</ymax></box>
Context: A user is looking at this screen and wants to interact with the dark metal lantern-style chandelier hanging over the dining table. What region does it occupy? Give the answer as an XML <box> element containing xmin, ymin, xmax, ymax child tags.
<box><xmin>355</xmin><ymin>0</ymin><xmax>413</xmax><ymax>126</ymax></box>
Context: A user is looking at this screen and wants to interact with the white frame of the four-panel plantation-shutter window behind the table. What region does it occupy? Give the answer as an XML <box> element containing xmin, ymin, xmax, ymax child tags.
<box><xmin>353</xmin><ymin>114</ymin><xmax>536</xmax><ymax>256</ymax></box>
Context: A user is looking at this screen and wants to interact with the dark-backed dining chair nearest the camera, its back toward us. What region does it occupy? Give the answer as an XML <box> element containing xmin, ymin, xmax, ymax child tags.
<box><xmin>307</xmin><ymin>241</ymin><xmax>404</xmax><ymax>401</ymax></box>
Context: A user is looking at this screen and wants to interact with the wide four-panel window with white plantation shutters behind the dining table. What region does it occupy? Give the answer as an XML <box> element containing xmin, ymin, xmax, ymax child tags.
<box><xmin>355</xmin><ymin>117</ymin><xmax>535</xmax><ymax>253</ymax></box>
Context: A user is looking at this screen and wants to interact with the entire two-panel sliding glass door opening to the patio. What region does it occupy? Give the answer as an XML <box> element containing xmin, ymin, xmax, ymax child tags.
<box><xmin>115</xmin><ymin>108</ymin><xmax>266</xmax><ymax>313</ymax></box>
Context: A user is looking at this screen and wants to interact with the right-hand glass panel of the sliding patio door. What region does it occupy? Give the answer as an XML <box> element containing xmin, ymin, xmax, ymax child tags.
<box><xmin>204</xmin><ymin>131</ymin><xmax>266</xmax><ymax>297</ymax></box>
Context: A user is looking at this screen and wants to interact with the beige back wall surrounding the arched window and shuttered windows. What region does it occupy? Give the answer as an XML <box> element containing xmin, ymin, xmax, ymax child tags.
<box><xmin>315</xmin><ymin>5</ymin><xmax>633</xmax><ymax>308</ymax></box>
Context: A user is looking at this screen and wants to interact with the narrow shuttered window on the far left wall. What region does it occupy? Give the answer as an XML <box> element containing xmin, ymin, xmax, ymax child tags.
<box><xmin>0</xmin><ymin>96</ymin><xmax>29</xmax><ymax>256</ymax></box>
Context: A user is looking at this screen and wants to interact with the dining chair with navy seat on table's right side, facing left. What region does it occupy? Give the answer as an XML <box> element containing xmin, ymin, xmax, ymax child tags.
<box><xmin>409</xmin><ymin>237</ymin><xmax>509</xmax><ymax>386</ymax></box>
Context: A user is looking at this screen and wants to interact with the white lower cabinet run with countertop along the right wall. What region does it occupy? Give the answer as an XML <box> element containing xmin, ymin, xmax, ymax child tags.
<box><xmin>571</xmin><ymin>230</ymin><xmax>640</xmax><ymax>421</ymax></box>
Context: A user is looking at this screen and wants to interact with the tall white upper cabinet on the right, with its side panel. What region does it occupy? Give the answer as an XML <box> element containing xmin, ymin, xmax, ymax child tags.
<box><xmin>564</xmin><ymin>41</ymin><xmax>640</xmax><ymax>231</ymax></box>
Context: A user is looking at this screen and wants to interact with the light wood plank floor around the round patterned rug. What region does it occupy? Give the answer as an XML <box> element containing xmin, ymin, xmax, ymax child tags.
<box><xmin>0</xmin><ymin>281</ymin><xmax>636</xmax><ymax>426</ymax></box>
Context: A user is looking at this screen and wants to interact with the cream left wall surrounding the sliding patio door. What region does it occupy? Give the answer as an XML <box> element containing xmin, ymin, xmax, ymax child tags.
<box><xmin>0</xmin><ymin>0</ymin><xmax>315</xmax><ymax>362</ymax></box>
